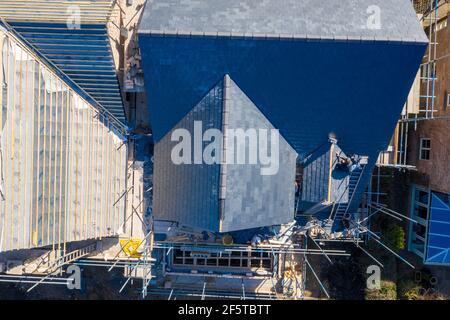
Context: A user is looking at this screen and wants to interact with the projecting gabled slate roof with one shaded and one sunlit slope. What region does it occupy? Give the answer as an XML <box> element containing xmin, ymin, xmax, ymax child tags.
<box><xmin>153</xmin><ymin>76</ymin><xmax>297</xmax><ymax>232</ymax></box>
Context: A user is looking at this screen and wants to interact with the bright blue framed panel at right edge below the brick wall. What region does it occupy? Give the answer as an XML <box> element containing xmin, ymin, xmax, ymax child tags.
<box><xmin>425</xmin><ymin>192</ymin><xmax>450</xmax><ymax>264</ymax></box>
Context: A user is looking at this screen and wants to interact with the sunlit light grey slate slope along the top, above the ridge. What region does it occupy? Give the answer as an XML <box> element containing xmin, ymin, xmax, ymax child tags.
<box><xmin>139</xmin><ymin>0</ymin><xmax>428</xmax><ymax>42</ymax></box>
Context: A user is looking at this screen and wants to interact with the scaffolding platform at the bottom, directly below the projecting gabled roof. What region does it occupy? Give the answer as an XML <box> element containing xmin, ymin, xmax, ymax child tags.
<box><xmin>148</xmin><ymin>223</ymin><xmax>350</xmax><ymax>300</ymax></box>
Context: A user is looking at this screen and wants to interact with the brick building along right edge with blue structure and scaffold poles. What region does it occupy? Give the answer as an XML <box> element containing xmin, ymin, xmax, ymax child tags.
<box><xmin>379</xmin><ymin>0</ymin><xmax>450</xmax><ymax>268</ymax></box>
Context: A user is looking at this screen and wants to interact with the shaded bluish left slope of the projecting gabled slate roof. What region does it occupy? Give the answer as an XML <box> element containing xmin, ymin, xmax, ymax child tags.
<box><xmin>153</xmin><ymin>77</ymin><xmax>223</xmax><ymax>230</ymax></box>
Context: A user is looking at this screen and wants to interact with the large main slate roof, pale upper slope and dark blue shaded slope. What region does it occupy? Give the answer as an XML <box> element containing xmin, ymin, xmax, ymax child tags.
<box><xmin>139</xmin><ymin>0</ymin><xmax>428</xmax><ymax>231</ymax></box>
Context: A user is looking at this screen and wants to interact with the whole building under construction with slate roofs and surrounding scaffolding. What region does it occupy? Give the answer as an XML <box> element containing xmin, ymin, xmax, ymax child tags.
<box><xmin>0</xmin><ymin>0</ymin><xmax>448</xmax><ymax>299</ymax></box>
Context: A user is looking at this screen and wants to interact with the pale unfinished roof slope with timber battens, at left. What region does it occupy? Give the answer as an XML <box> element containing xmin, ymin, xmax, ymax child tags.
<box><xmin>0</xmin><ymin>21</ymin><xmax>127</xmax><ymax>255</ymax></box>
